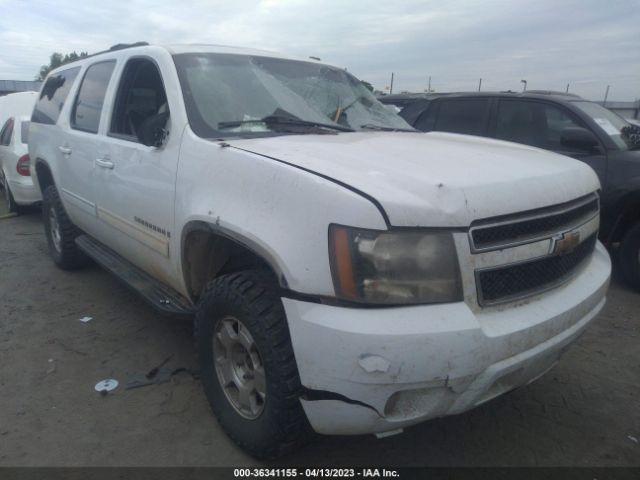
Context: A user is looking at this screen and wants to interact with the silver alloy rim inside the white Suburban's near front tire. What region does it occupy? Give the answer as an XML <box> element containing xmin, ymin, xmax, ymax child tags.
<box><xmin>213</xmin><ymin>316</ymin><xmax>267</xmax><ymax>420</ymax></box>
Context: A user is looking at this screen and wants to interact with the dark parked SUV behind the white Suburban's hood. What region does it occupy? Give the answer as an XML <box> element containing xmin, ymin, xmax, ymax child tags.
<box><xmin>382</xmin><ymin>92</ymin><xmax>640</xmax><ymax>290</ymax></box>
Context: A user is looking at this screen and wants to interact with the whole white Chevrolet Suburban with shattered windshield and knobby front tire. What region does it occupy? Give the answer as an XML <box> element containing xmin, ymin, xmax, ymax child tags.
<box><xmin>29</xmin><ymin>44</ymin><xmax>611</xmax><ymax>457</ymax></box>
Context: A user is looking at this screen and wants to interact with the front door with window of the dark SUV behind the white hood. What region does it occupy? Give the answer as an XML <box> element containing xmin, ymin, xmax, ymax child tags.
<box><xmin>492</xmin><ymin>99</ymin><xmax>607</xmax><ymax>185</ymax></box>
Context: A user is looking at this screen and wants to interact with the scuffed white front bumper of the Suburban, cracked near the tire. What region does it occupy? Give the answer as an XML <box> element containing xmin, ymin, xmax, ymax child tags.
<box><xmin>283</xmin><ymin>243</ymin><xmax>611</xmax><ymax>435</ymax></box>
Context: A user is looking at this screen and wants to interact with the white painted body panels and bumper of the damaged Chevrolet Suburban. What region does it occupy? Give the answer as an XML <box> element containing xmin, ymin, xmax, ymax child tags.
<box><xmin>29</xmin><ymin>46</ymin><xmax>611</xmax><ymax>434</ymax></box>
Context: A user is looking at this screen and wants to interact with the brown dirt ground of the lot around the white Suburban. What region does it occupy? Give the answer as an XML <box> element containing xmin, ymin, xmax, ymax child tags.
<box><xmin>0</xmin><ymin>198</ymin><xmax>640</xmax><ymax>466</ymax></box>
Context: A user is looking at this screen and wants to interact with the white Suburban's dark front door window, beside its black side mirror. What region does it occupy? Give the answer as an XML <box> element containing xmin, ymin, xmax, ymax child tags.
<box><xmin>110</xmin><ymin>58</ymin><xmax>169</xmax><ymax>141</ymax></box>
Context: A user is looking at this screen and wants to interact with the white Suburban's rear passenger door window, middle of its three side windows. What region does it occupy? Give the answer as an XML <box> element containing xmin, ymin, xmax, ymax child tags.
<box><xmin>71</xmin><ymin>60</ymin><xmax>116</xmax><ymax>133</ymax></box>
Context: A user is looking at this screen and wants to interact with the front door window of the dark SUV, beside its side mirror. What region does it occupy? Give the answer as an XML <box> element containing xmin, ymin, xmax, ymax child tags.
<box><xmin>496</xmin><ymin>100</ymin><xmax>581</xmax><ymax>150</ymax></box>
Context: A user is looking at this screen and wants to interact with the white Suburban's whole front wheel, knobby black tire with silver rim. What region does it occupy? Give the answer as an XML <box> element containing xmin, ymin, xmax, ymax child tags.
<box><xmin>195</xmin><ymin>270</ymin><xmax>310</xmax><ymax>458</ymax></box>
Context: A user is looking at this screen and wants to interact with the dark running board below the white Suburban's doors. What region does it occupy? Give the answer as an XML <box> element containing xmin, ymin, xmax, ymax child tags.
<box><xmin>76</xmin><ymin>235</ymin><xmax>195</xmax><ymax>316</ymax></box>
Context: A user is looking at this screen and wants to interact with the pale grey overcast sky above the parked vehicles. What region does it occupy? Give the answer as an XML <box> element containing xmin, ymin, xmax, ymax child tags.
<box><xmin>0</xmin><ymin>0</ymin><xmax>640</xmax><ymax>100</ymax></box>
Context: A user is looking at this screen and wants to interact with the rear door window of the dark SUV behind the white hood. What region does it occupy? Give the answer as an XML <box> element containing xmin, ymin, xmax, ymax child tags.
<box><xmin>434</xmin><ymin>98</ymin><xmax>489</xmax><ymax>135</ymax></box>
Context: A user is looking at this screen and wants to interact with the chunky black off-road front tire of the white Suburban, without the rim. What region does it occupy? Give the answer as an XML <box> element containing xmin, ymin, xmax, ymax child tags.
<box><xmin>194</xmin><ymin>270</ymin><xmax>311</xmax><ymax>459</ymax></box>
